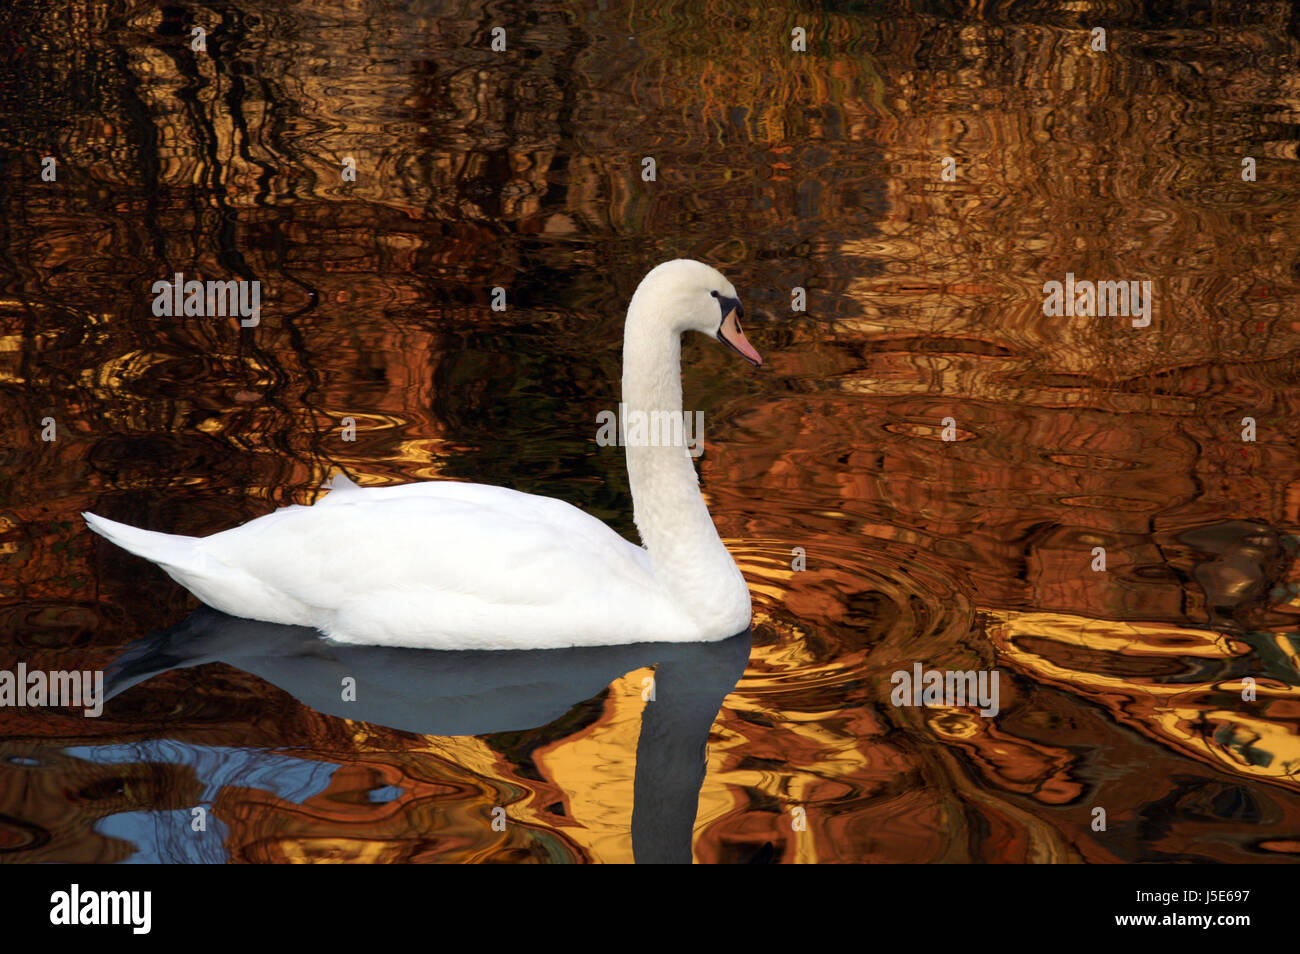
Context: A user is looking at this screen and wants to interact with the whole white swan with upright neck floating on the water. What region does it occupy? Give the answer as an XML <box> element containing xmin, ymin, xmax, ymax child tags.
<box><xmin>82</xmin><ymin>259</ymin><xmax>762</xmax><ymax>650</ymax></box>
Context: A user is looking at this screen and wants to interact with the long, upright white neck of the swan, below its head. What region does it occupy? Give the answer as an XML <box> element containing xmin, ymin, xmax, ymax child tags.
<box><xmin>621</xmin><ymin>295</ymin><xmax>749</xmax><ymax>619</ymax></box>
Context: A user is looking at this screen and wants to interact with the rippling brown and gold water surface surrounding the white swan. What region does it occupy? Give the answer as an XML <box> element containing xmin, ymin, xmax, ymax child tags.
<box><xmin>0</xmin><ymin>0</ymin><xmax>1300</xmax><ymax>862</ymax></box>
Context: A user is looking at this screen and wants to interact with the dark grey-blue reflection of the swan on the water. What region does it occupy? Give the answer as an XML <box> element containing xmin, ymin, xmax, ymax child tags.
<box><xmin>105</xmin><ymin>607</ymin><xmax>750</xmax><ymax>863</ymax></box>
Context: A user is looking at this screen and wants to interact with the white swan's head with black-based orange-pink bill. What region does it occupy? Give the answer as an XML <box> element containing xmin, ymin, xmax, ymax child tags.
<box><xmin>632</xmin><ymin>259</ymin><xmax>763</xmax><ymax>367</ymax></box>
